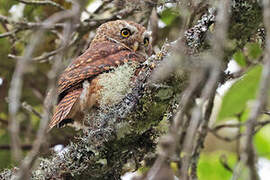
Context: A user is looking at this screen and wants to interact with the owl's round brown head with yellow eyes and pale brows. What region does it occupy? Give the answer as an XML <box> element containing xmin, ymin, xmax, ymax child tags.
<box><xmin>91</xmin><ymin>20</ymin><xmax>152</xmax><ymax>57</ymax></box>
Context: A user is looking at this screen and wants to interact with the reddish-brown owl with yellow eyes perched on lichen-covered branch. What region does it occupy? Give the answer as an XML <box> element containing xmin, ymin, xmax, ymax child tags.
<box><xmin>48</xmin><ymin>20</ymin><xmax>152</xmax><ymax>130</ymax></box>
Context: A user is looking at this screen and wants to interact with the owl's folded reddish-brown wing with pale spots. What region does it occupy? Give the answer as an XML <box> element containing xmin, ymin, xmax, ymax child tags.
<box><xmin>58</xmin><ymin>41</ymin><xmax>145</xmax><ymax>97</ymax></box>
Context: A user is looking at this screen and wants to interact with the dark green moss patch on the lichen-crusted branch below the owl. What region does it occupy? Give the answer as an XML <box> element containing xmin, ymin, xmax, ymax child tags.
<box><xmin>129</xmin><ymin>75</ymin><xmax>187</xmax><ymax>134</ymax></box>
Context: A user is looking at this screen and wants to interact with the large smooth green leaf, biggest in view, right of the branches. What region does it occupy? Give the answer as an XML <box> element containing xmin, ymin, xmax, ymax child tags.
<box><xmin>218</xmin><ymin>65</ymin><xmax>262</xmax><ymax>121</ymax></box>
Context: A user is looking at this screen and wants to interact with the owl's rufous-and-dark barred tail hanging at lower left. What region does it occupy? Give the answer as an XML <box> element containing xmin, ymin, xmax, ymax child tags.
<box><xmin>48</xmin><ymin>89</ymin><xmax>82</xmax><ymax>131</ymax></box>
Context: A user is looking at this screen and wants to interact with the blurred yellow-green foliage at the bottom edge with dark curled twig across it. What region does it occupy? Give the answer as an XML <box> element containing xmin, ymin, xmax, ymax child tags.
<box><xmin>198</xmin><ymin>152</ymin><xmax>236</xmax><ymax>180</ymax></box>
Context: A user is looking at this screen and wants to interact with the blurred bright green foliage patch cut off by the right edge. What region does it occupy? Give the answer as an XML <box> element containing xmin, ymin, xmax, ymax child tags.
<box><xmin>254</xmin><ymin>125</ymin><xmax>270</xmax><ymax>159</ymax></box>
